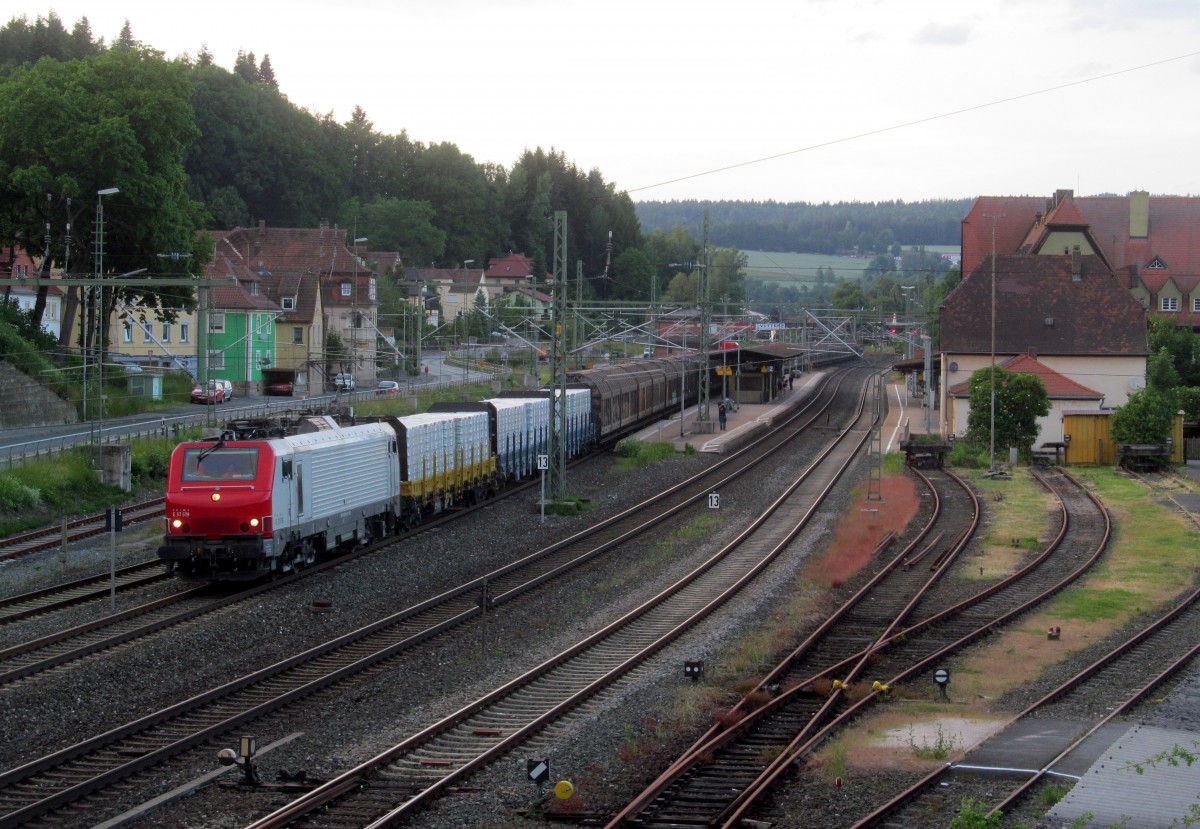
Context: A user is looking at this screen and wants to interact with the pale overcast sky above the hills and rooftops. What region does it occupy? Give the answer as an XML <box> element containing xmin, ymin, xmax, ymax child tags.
<box><xmin>14</xmin><ymin>0</ymin><xmax>1200</xmax><ymax>203</ymax></box>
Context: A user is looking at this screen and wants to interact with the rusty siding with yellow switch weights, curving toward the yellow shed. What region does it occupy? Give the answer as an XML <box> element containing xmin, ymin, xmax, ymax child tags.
<box><xmin>608</xmin><ymin>473</ymin><xmax>1110</xmax><ymax>829</ymax></box>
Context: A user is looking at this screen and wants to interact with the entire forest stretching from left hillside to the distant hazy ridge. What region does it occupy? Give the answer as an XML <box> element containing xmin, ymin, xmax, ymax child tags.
<box><xmin>0</xmin><ymin>12</ymin><xmax>967</xmax><ymax>328</ymax></box>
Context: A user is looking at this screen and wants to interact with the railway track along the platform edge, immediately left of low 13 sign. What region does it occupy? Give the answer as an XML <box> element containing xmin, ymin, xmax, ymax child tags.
<box><xmin>0</xmin><ymin>367</ymin><xmax>878</xmax><ymax>827</ymax></box>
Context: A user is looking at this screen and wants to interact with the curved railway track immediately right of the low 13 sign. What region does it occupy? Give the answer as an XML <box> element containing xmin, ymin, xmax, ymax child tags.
<box><xmin>243</xmin><ymin>371</ymin><xmax>871</xmax><ymax>829</ymax></box>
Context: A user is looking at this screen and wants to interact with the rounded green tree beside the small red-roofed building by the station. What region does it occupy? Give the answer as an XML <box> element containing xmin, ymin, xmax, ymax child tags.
<box><xmin>967</xmin><ymin>366</ymin><xmax>1050</xmax><ymax>455</ymax></box>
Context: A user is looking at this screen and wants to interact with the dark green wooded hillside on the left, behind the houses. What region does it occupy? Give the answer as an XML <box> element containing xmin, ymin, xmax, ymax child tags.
<box><xmin>0</xmin><ymin>12</ymin><xmax>667</xmax><ymax>311</ymax></box>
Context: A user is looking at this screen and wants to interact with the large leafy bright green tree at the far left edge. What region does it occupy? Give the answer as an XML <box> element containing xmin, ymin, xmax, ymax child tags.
<box><xmin>0</xmin><ymin>48</ymin><xmax>204</xmax><ymax>343</ymax></box>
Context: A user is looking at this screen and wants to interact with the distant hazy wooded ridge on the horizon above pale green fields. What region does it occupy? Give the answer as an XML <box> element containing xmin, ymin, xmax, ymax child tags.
<box><xmin>637</xmin><ymin>199</ymin><xmax>971</xmax><ymax>254</ymax></box>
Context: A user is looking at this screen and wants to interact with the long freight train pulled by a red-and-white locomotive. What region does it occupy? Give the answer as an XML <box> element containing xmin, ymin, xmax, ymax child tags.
<box><xmin>158</xmin><ymin>359</ymin><xmax>698</xmax><ymax>581</ymax></box>
